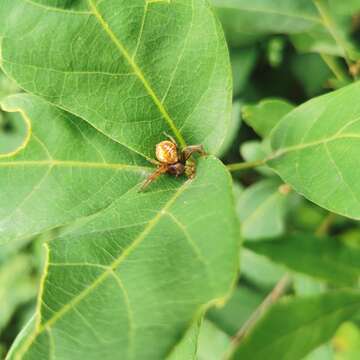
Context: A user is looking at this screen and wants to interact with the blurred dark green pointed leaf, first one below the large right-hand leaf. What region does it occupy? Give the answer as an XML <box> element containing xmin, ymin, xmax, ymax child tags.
<box><xmin>246</xmin><ymin>235</ymin><xmax>360</xmax><ymax>285</ymax></box>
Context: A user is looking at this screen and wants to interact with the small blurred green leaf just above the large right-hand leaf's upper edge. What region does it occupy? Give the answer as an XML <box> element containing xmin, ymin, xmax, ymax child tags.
<box><xmin>242</xmin><ymin>99</ymin><xmax>294</xmax><ymax>138</ymax></box>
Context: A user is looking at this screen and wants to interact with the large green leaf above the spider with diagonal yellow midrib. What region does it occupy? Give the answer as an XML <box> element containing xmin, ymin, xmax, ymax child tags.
<box><xmin>0</xmin><ymin>0</ymin><xmax>231</xmax><ymax>158</ymax></box>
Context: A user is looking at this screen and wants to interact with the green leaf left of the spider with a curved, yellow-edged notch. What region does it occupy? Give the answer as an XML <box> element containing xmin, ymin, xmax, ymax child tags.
<box><xmin>0</xmin><ymin>95</ymin><xmax>151</xmax><ymax>243</ymax></box>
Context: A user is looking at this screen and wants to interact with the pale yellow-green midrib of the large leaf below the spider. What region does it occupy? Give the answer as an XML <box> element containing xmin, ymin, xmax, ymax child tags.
<box><xmin>16</xmin><ymin>180</ymin><xmax>190</xmax><ymax>359</ymax></box>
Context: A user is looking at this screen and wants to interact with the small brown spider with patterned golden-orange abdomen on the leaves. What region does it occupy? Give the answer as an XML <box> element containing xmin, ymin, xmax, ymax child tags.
<box><xmin>140</xmin><ymin>134</ymin><xmax>206</xmax><ymax>191</ymax></box>
